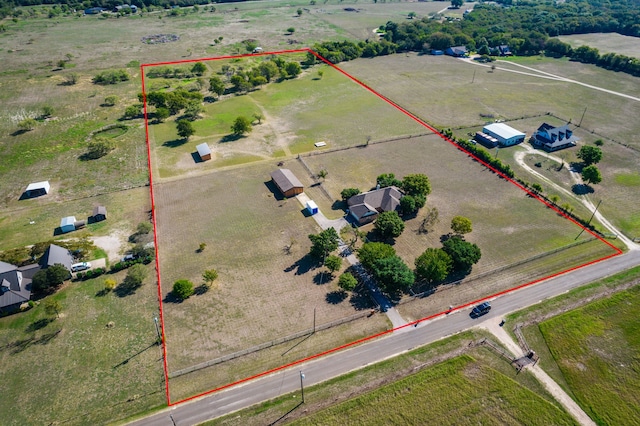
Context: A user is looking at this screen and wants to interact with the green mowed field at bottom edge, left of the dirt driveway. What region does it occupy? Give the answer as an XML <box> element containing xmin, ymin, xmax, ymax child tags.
<box><xmin>293</xmin><ymin>355</ymin><xmax>577</xmax><ymax>425</ymax></box>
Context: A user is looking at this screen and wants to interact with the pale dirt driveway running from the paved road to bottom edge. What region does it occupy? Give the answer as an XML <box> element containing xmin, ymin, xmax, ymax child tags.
<box><xmin>478</xmin><ymin>318</ymin><xmax>596</xmax><ymax>426</ymax></box>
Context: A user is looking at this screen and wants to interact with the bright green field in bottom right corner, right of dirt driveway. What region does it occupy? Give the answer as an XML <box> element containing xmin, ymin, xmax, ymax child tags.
<box><xmin>540</xmin><ymin>286</ymin><xmax>640</xmax><ymax>425</ymax></box>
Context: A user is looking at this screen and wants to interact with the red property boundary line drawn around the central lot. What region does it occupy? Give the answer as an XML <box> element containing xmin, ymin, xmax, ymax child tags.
<box><xmin>140</xmin><ymin>48</ymin><xmax>623</xmax><ymax>407</ymax></box>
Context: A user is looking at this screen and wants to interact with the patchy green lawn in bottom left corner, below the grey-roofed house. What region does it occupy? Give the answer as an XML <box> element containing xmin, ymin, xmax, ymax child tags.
<box><xmin>0</xmin><ymin>271</ymin><xmax>165</xmax><ymax>425</ymax></box>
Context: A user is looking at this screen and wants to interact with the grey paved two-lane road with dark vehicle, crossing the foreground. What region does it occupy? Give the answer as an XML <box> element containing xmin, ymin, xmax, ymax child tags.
<box><xmin>132</xmin><ymin>251</ymin><xmax>640</xmax><ymax>426</ymax></box>
